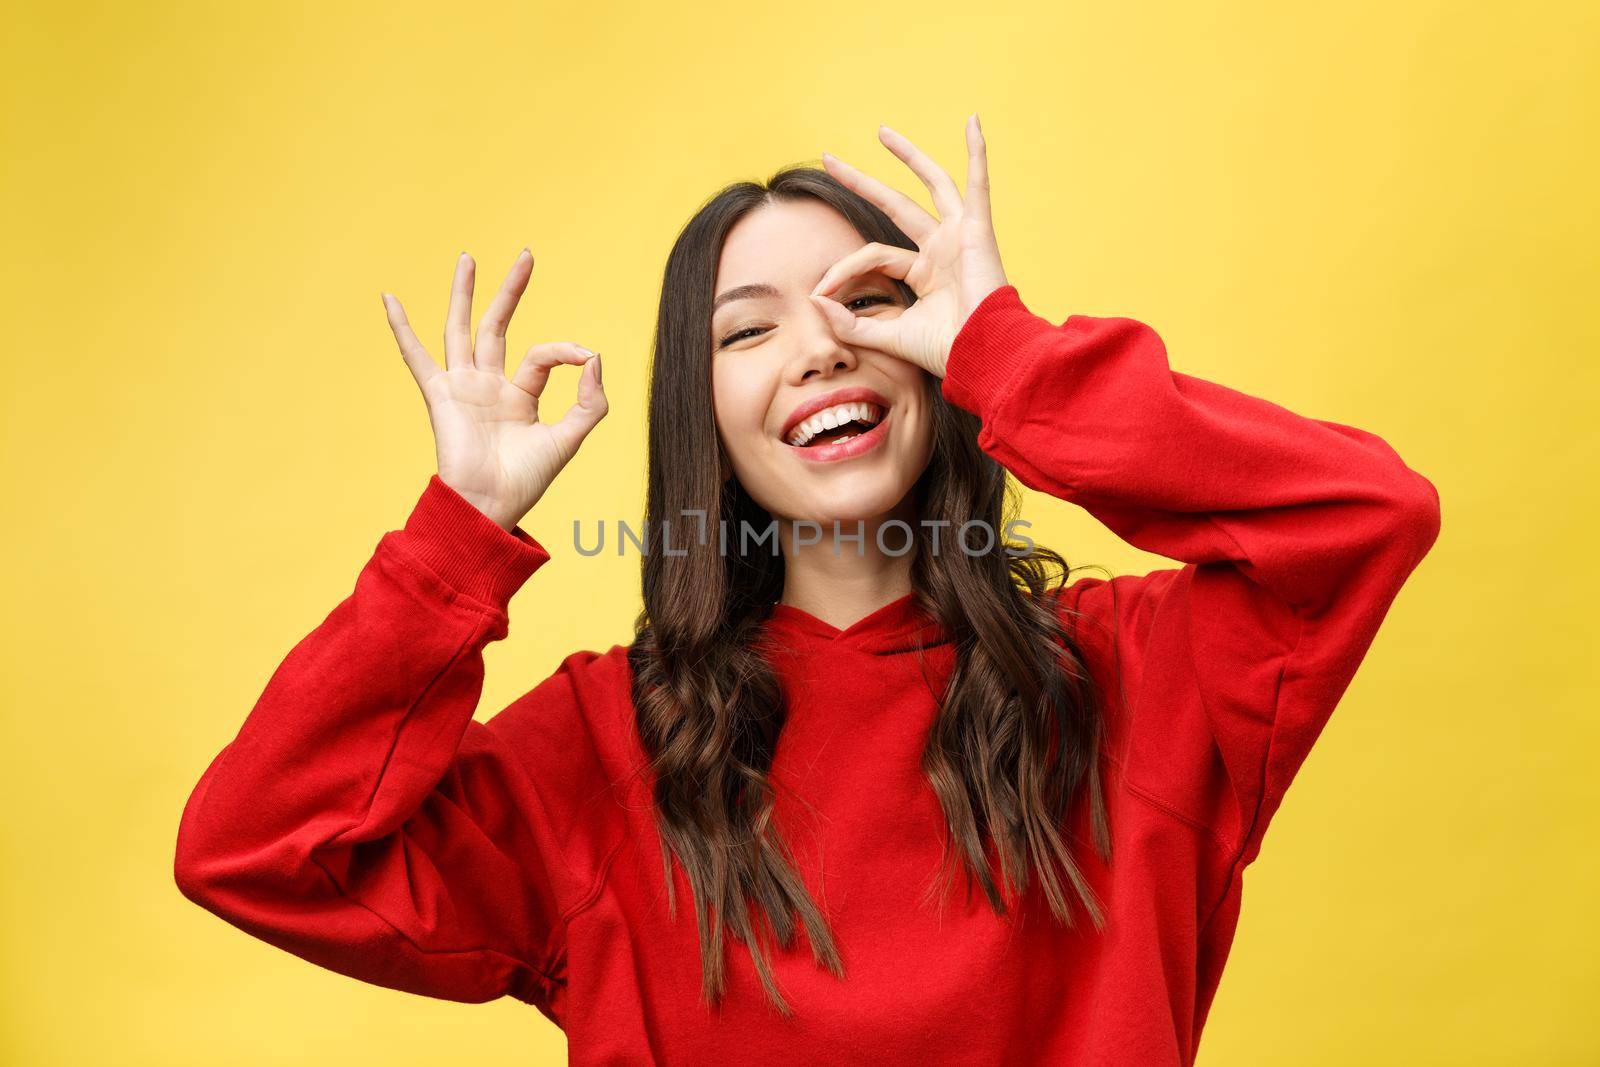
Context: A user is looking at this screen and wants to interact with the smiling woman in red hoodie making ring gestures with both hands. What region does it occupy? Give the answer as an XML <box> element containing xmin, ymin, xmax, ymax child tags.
<box><xmin>176</xmin><ymin>115</ymin><xmax>1440</xmax><ymax>1065</ymax></box>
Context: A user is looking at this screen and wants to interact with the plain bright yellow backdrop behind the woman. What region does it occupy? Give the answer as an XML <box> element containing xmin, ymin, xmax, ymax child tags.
<box><xmin>0</xmin><ymin>0</ymin><xmax>1600</xmax><ymax>1067</ymax></box>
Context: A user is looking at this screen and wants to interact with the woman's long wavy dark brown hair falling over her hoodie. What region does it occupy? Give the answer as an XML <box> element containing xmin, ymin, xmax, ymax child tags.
<box><xmin>629</xmin><ymin>166</ymin><xmax>1110</xmax><ymax>1014</ymax></box>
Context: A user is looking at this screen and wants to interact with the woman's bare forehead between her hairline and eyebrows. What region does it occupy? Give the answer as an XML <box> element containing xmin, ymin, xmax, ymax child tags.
<box><xmin>717</xmin><ymin>197</ymin><xmax>867</xmax><ymax>291</ymax></box>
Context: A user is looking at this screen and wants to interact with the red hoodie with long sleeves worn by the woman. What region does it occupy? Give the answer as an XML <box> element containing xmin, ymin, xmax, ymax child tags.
<box><xmin>174</xmin><ymin>286</ymin><xmax>1440</xmax><ymax>1067</ymax></box>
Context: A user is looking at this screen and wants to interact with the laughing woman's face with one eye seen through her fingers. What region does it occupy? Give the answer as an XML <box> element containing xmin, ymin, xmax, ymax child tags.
<box><xmin>712</xmin><ymin>198</ymin><xmax>933</xmax><ymax>531</ymax></box>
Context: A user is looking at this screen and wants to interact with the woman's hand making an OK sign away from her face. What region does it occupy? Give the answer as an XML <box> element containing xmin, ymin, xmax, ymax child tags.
<box><xmin>384</xmin><ymin>248</ymin><xmax>608</xmax><ymax>531</ymax></box>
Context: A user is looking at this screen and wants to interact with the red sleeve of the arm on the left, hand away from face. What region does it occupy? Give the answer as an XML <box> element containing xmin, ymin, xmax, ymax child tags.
<box><xmin>174</xmin><ymin>475</ymin><xmax>584</xmax><ymax>1017</ymax></box>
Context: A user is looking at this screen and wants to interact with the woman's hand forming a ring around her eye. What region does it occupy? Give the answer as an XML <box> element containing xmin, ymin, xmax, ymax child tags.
<box><xmin>811</xmin><ymin>114</ymin><xmax>1008</xmax><ymax>378</ymax></box>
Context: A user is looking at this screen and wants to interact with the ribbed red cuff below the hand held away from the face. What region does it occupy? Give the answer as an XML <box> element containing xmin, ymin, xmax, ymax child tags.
<box><xmin>394</xmin><ymin>474</ymin><xmax>550</xmax><ymax>611</ymax></box>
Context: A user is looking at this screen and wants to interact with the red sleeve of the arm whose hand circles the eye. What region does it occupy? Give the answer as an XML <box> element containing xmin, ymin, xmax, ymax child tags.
<box><xmin>942</xmin><ymin>286</ymin><xmax>1440</xmax><ymax>865</ymax></box>
